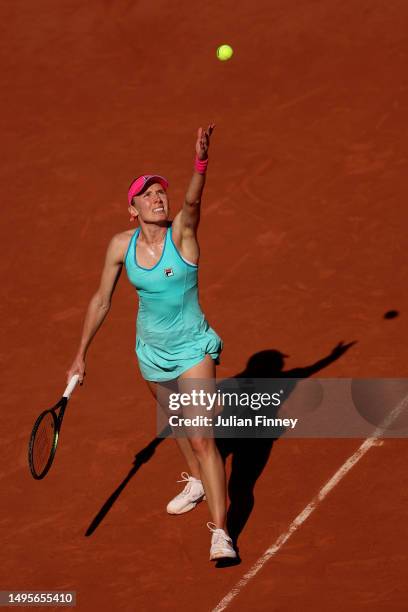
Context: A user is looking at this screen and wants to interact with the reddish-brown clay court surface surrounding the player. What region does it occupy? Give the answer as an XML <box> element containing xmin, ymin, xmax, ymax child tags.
<box><xmin>0</xmin><ymin>0</ymin><xmax>408</xmax><ymax>612</ymax></box>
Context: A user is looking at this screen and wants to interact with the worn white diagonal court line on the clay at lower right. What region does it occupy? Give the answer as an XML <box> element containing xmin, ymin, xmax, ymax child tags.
<box><xmin>212</xmin><ymin>395</ymin><xmax>408</xmax><ymax>612</ymax></box>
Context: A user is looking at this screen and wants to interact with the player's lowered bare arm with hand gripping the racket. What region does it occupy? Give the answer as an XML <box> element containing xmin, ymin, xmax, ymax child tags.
<box><xmin>67</xmin><ymin>234</ymin><xmax>126</xmax><ymax>384</ymax></box>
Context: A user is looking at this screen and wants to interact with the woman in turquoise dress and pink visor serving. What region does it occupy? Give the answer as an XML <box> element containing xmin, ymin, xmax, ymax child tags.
<box><xmin>67</xmin><ymin>124</ymin><xmax>236</xmax><ymax>560</ymax></box>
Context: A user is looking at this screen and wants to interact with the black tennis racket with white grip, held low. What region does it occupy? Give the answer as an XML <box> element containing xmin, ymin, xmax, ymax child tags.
<box><xmin>28</xmin><ymin>374</ymin><xmax>79</xmax><ymax>480</ymax></box>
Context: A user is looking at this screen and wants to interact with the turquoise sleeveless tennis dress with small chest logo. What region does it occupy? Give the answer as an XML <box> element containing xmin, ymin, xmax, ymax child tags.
<box><xmin>125</xmin><ymin>226</ymin><xmax>223</xmax><ymax>382</ymax></box>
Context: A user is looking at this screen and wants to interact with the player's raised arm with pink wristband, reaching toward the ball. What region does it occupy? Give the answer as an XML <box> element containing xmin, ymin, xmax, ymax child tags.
<box><xmin>173</xmin><ymin>123</ymin><xmax>215</xmax><ymax>240</ymax></box>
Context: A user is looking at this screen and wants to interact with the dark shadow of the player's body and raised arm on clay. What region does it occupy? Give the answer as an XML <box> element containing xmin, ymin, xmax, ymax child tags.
<box><xmin>216</xmin><ymin>342</ymin><xmax>355</xmax><ymax>567</ymax></box>
